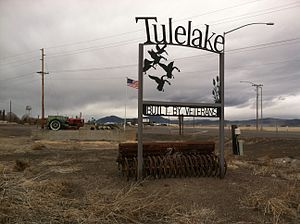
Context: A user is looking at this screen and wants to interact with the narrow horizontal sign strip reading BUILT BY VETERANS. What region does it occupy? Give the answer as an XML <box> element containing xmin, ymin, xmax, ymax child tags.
<box><xmin>143</xmin><ymin>105</ymin><xmax>220</xmax><ymax>117</ymax></box>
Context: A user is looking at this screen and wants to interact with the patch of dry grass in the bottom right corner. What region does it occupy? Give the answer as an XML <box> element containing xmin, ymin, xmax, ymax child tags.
<box><xmin>240</xmin><ymin>184</ymin><xmax>300</xmax><ymax>224</ymax></box>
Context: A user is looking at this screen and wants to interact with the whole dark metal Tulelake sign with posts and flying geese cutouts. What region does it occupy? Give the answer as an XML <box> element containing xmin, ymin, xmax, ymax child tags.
<box><xmin>135</xmin><ymin>17</ymin><xmax>225</xmax><ymax>178</ymax></box>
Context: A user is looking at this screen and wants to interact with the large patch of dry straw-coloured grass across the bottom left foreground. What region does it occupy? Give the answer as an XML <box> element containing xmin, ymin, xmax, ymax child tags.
<box><xmin>0</xmin><ymin>169</ymin><xmax>218</xmax><ymax>224</ymax></box>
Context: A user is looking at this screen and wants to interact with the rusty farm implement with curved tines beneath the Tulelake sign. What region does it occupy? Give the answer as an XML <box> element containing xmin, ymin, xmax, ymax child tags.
<box><xmin>117</xmin><ymin>141</ymin><xmax>227</xmax><ymax>180</ymax></box>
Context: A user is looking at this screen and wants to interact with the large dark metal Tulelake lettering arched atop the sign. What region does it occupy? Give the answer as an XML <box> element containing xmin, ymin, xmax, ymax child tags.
<box><xmin>135</xmin><ymin>17</ymin><xmax>224</xmax><ymax>53</ymax></box>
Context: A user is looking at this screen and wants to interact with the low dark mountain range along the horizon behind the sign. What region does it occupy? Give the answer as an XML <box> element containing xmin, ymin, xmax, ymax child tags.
<box><xmin>96</xmin><ymin>115</ymin><xmax>300</xmax><ymax>127</ymax></box>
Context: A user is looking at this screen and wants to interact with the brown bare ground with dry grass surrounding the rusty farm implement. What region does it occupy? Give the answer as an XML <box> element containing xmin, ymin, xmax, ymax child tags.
<box><xmin>0</xmin><ymin>125</ymin><xmax>300</xmax><ymax>224</ymax></box>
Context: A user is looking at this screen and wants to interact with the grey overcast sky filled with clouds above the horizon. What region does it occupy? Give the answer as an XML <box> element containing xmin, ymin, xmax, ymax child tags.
<box><xmin>0</xmin><ymin>0</ymin><xmax>300</xmax><ymax>120</ymax></box>
